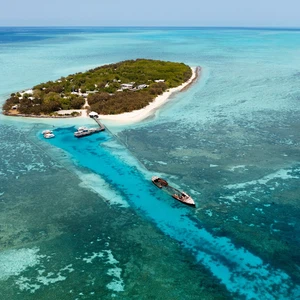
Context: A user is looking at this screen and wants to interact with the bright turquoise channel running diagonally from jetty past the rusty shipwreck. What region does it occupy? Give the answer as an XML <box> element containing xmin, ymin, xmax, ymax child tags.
<box><xmin>41</xmin><ymin>128</ymin><xmax>299</xmax><ymax>298</ymax></box>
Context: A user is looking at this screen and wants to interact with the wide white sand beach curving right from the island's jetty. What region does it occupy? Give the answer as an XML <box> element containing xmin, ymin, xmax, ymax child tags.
<box><xmin>95</xmin><ymin>67</ymin><xmax>201</xmax><ymax>124</ymax></box>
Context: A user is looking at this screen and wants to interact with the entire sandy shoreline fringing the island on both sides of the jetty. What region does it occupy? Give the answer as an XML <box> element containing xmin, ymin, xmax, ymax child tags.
<box><xmin>2</xmin><ymin>66</ymin><xmax>202</xmax><ymax>125</ymax></box>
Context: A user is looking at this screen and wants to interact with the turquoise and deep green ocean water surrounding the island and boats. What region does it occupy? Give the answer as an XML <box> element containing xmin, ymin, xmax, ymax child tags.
<box><xmin>0</xmin><ymin>27</ymin><xmax>300</xmax><ymax>299</ymax></box>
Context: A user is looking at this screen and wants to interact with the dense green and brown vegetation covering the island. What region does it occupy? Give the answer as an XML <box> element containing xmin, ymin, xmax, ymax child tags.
<box><xmin>3</xmin><ymin>59</ymin><xmax>192</xmax><ymax>115</ymax></box>
